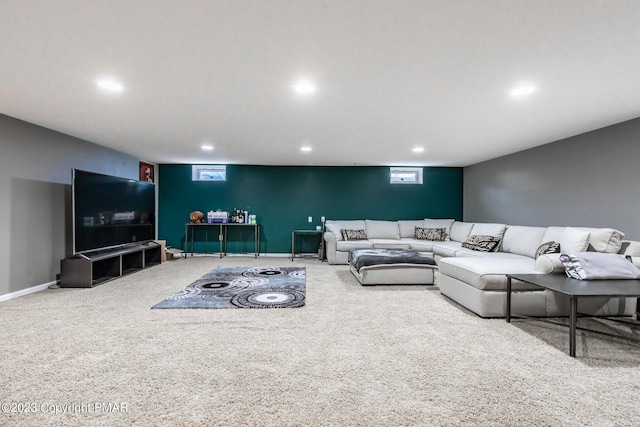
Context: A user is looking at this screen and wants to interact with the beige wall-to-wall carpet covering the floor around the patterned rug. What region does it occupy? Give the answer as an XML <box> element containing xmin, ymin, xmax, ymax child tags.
<box><xmin>0</xmin><ymin>257</ymin><xmax>640</xmax><ymax>426</ymax></box>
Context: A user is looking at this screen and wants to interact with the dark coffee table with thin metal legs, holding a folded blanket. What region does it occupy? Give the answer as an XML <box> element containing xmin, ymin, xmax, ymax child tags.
<box><xmin>506</xmin><ymin>274</ymin><xmax>640</xmax><ymax>357</ymax></box>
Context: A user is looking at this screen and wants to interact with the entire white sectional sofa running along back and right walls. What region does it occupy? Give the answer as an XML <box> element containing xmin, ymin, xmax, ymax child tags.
<box><xmin>324</xmin><ymin>219</ymin><xmax>640</xmax><ymax>317</ymax></box>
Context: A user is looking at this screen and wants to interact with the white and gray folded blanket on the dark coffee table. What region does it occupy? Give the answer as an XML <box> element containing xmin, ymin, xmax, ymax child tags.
<box><xmin>560</xmin><ymin>252</ymin><xmax>640</xmax><ymax>280</ymax></box>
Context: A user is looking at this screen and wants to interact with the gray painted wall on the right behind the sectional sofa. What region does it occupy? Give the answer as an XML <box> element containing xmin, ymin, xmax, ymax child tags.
<box><xmin>463</xmin><ymin>118</ymin><xmax>640</xmax><ymax>240</ymax></box>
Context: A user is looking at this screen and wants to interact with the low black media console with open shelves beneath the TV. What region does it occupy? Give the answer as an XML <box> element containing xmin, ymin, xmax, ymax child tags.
<box><xmin>60</xmin><ymin>242</ymin><xmax>162</xmax><ymax>288</ymax></box>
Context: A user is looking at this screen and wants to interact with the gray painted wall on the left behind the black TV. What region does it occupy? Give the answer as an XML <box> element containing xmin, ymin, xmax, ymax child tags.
<box><xmin>0</xmin><ymin>114</ymin><xmax>139</xmax><ymax>295</ymax></box>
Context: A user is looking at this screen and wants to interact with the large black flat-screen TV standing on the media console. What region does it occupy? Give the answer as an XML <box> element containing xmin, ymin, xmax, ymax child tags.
<box><xmin>72</xmin><ymin>169</ymin><xmax>156</xmax><ymax>253</ymax></box>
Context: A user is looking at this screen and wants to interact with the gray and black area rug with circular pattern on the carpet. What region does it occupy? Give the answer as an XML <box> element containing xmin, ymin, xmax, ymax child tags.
<box><xmin>151</xmin><ymin>267</ymin><xmax>306</xmax><ymax>308</ymax></box>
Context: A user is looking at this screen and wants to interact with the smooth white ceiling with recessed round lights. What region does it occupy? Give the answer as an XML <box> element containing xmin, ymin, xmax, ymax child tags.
<box><xmin>0</xmin><ymin>0</ymin><xmax>640</xmax><ymax>166</ymax></box>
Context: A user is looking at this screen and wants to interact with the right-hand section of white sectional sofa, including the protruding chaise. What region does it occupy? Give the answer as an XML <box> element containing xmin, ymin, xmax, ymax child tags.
<box><xmin>434</xmin><ymin>224</ymin><xmax>640</xmax><ymax>317</ymax></box>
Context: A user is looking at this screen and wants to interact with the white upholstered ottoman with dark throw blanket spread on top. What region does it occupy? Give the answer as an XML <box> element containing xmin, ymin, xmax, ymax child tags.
<box><xmin>348</xmin><ymin>249</ymin><xmax>438</xmax><ymax>286</ymax></box>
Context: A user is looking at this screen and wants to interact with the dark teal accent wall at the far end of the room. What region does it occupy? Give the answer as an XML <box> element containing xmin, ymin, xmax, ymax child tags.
<box><xmin>158</xmin><ymin>164</ymin><xmax>463</xmax><ymax>253</ymax></box>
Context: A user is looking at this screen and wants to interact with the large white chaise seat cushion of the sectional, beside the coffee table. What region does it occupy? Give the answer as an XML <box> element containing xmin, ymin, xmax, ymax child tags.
<box><xmin>439</xmin><ymin>256</ymin><xmax>540</xmax><ymax>291</ymax></box>
